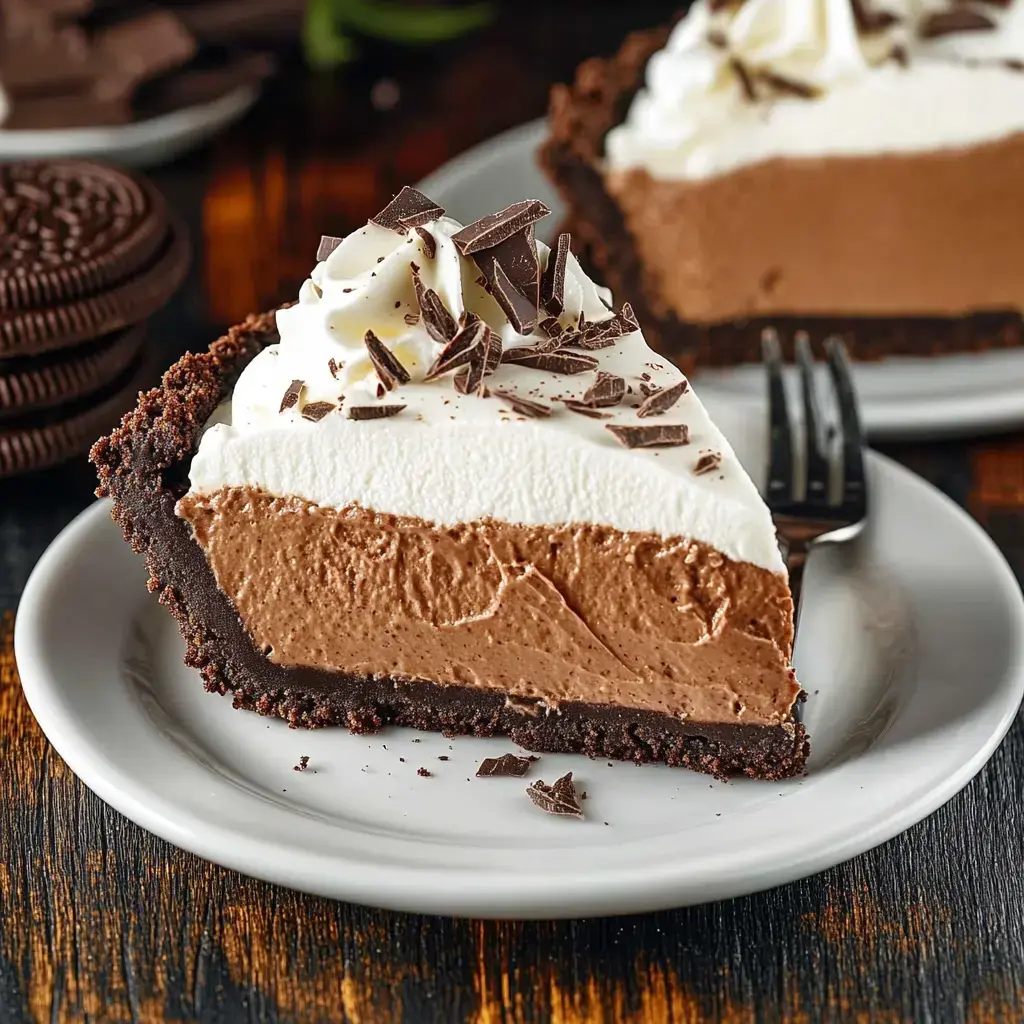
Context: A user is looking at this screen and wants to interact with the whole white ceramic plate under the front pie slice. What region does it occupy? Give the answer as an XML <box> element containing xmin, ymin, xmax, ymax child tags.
<box><xmin>14</xmin><ymin>399</ymin><xmax>1024</xmax><ymax>918</ymax></box>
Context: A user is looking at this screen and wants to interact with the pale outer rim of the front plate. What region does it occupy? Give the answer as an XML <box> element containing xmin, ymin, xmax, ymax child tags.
<box><xmin>14</xmin><ymin>453</ymin><xmax>1024</xmax><ymax>919</ymax></box>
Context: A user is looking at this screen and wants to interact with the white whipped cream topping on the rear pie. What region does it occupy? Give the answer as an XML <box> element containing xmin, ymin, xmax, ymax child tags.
<box><xmin>606</xmin><ymin>0</ymin><xmax>1024</xmax><ymax>179</ymax></box>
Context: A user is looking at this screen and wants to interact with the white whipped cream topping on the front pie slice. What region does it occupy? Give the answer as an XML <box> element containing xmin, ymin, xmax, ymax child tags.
<box><xmin>189</xmin><ymin>195</ymin><xmax>784</xmax><ymax>572</ymax></box>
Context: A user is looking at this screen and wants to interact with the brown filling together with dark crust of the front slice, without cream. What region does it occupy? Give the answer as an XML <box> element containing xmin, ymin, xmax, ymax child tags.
<box><xmin>91</xmin><ymin>313</ymin><xmax>808</xmax><ymax>778</ymax></box>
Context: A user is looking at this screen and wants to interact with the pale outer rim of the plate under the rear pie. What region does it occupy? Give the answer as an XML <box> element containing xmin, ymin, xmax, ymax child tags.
<box><xmin>416</xmin><ymin>117</ymin><xmax>1024</xmax><ymax>440</ymax></box>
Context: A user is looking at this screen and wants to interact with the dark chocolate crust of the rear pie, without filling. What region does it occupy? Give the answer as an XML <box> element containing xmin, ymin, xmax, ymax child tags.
<box><xmin>540</xmin><ymin>27</ymin><xmax>1024</xmax><ymax>372</ymax></box>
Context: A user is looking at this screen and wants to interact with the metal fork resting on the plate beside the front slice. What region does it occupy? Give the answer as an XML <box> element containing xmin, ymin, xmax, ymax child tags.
<box><xmin>761</xmin><ymin>330</ymin><xmax>867</xmax><ymax>617</ymax></box>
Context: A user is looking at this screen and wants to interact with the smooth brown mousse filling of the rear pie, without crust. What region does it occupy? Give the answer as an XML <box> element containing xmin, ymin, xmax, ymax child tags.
<box><xmin>605</xmin><ymin>133</ymin><xmax>1024</xmax><ymax>324</ymax></box>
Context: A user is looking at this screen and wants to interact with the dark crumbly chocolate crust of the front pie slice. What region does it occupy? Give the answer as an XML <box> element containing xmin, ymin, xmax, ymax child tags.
<box><xmin>90</xmin><ymin>313</ymin><xmax>808</xmax><ymax>779</ymax></box>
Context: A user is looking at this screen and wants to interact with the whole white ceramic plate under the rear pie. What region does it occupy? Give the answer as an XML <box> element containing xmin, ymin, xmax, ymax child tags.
<box><xmin>418</xmin><ymin>121</ymin><xmax>1024</xmax><ymax>438</ymax></box>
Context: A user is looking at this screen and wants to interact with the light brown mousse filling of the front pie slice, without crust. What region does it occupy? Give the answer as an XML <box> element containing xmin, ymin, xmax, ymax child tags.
<box><xmin>178</xmin><ymin>487</ymin><xmax>800</xmax><ymax>725</ymax></box>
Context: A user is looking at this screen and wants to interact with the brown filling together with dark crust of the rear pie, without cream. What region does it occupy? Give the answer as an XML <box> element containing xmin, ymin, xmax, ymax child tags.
<box><xmin>541</xmin><ymin>28</ymin><xmax>1024</xmax><ymax>370</ymax></box>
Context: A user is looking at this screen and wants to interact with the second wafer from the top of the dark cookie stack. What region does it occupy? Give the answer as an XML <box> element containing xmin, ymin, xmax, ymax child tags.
<box><xmin>0</xmin><ymin>215</ymin><xmax>188</xmax><ymax>358</ymax></box>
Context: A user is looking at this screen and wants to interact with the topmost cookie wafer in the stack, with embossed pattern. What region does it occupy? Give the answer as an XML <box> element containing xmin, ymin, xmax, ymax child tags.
<box><xmin>0</xmin><ymin>160</ymin><xmax>167</xmax><ymax>313</ymax></box>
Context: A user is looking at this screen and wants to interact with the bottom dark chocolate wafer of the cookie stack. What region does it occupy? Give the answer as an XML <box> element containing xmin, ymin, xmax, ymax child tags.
<box><xmin>0</xmin><ymin>355</ymin><xmax>156</xmax><ymax>478</ymax></box>
